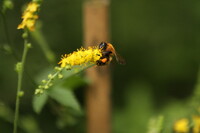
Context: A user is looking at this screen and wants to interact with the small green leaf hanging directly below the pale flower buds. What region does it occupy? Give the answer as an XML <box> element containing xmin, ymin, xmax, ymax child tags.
<box><xmin>33</xmin><ymin>93</ymin><xmax>48</xmax><ymax>114</ymax></box>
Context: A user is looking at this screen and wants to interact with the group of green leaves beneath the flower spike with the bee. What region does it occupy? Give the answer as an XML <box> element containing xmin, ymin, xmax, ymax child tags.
<box><xmin>33</xmin><ymin>62</ymin><xmax>90</xmax><ymax>113</ymax></box>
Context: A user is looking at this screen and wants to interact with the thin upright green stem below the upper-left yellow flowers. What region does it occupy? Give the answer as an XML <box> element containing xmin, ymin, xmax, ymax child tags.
<box><xmin>13</xmin><ymin>31</ymin><xmax>30</xmax><ymax>133</ymax></box>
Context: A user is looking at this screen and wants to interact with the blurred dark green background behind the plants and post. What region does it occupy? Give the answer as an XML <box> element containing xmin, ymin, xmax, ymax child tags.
<box><xmin>0</xmin><ymin>0</ymin><xmax>200</xmax><ymax>133</ymax></box>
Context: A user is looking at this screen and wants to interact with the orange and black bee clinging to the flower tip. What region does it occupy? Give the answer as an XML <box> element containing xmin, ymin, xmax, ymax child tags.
<box><xmin>96</xmin><ymin>42</ymin><xmax>126</xmax><ymax>66</ymax></box>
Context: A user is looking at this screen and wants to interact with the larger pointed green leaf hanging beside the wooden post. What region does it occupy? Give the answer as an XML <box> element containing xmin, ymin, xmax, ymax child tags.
<box><xmin>48</xmin><ymin>87</ymin><xmax>80</xmax><ymax>111</ymax></box>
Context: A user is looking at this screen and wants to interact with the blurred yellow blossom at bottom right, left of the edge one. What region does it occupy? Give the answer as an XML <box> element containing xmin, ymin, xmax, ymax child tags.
<box><xmin>174</xmin><ymin>118</ymin><xmax>189</xmax><ymax>133</ymax></box>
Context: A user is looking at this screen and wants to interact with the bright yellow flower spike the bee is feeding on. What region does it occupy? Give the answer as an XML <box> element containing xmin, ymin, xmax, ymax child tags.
<box><xmin>58</xmin><ymin>47</ymin><xmax>102</xmax><ymax>67</ymax></box>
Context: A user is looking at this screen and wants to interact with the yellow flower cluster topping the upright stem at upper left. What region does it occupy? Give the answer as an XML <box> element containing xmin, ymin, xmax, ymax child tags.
<box><xmin>17</xmin><ymin>2</ymin><xmax>39</xmax><ymax>31</ymax></box>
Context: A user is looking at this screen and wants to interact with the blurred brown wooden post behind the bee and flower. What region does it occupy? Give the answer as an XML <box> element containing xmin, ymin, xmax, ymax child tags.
<box><xmin>83</xmin><ymin>0</ymin><xmax>111</xmax><ymax>133</ymax></box>
